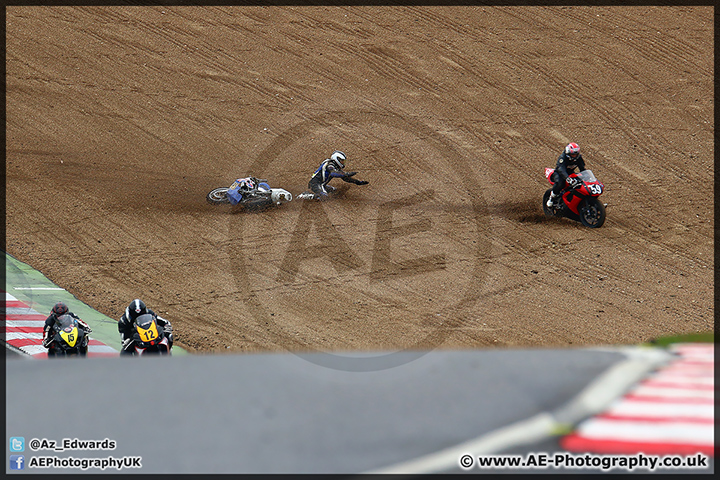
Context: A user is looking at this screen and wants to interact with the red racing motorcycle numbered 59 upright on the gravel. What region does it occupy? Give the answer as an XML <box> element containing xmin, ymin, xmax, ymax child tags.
<box><xmin>543</xmin><ymin>168</ymin><xmax>605</xmax><ymax>228</ymax></box>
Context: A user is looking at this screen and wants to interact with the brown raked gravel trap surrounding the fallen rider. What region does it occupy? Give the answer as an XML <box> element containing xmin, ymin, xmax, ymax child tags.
<box><xmin>6</xmin><ymin>6</ymin><xmax>714</xmax><ymax>353</ymax></box>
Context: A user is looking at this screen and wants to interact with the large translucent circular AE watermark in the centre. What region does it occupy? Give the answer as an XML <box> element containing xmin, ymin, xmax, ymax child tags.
<box><xmin>228</xmin><ymin>111</ymin><xmax>490</xmax><ymax>371</ymax></box>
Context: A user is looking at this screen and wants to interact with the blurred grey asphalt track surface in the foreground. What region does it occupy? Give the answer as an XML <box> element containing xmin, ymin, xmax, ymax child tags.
<box><xmin>7</xmin><ymin>349</ymin><xmax>708</xmax><ymax>474</ymax></box>
